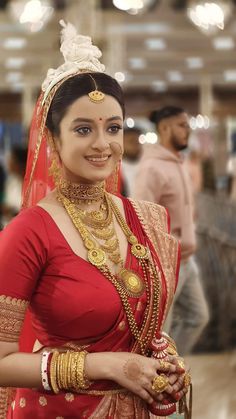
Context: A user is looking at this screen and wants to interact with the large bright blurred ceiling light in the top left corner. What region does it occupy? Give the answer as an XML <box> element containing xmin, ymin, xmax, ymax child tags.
<box><xmin>9</xmin><ymin>0</ymin><xmax>54</xmax><ymax>32</ymax></box>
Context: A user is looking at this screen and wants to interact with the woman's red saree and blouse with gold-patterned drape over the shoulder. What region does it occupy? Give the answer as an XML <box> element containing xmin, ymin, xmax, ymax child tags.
<box><xmin>0</xmin><ymin>195</ymin><xmax>179</xmax><ymax>419</ymax></box>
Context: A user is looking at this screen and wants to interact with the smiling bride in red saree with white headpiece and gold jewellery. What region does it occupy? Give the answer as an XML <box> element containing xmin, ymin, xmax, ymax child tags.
<box><xmin>0</xmin><ymin>20</ymin><xmax>188</xmax><ymax>419</ymax></box>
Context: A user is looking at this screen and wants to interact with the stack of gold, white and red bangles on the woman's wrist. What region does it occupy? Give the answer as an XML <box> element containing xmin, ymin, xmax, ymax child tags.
<box><xmin>41</xmin><ymin>351</ymin><xmax>91</xmax><ymax>394</ymax></box>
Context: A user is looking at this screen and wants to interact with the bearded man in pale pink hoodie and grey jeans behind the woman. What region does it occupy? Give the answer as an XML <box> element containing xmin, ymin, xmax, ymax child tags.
<box><xmin>134</xmin><ymin>106</ymin><xmax>209</xmax><ymax>355</ymax></box>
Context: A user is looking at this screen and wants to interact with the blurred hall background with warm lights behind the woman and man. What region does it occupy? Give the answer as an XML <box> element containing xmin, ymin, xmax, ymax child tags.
<box><xmin>0</xmin><ymin>0</ymin><xmax>236</xmax><ymax>419</ymax></box>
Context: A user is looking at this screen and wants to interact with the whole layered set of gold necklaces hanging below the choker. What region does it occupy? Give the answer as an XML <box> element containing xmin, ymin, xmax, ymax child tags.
<box><xmin>57</xmin><ymin>188</ymin><xmax>160</xmax><ymax>354</ymax></box>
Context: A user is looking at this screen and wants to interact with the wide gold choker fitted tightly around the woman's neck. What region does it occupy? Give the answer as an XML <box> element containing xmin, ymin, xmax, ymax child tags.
<box><xmin>58</xmin><ymin>179</ymin><xmax>105</xmax><ymax>205</ymax></box>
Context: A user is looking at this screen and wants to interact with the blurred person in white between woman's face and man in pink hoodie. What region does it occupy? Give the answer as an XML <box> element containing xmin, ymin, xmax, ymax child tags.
<box><xmin>122</xmin><ymin>127</ymin><xmax>142</xmax><ymax>197</ymax></box>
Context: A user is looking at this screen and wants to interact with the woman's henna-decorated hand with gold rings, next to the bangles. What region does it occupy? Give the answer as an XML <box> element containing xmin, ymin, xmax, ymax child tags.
<box><xmin>85</xmin><ymin>352</ymin><xmax>184</xmax><ymax>403</ymax></box>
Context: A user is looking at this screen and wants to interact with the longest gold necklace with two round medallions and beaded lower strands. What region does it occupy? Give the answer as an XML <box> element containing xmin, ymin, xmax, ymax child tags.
<box><xmin>58</xmin><ymin>191</ymin><xmax>160</xmax><ymax>354</ymax></box>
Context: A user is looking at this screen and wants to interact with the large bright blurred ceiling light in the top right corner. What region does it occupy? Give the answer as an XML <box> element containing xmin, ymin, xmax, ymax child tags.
<box><xmin>187</xmin><ymin>0</ymin><xmax>233</xmax><ymax>34</ymax></box>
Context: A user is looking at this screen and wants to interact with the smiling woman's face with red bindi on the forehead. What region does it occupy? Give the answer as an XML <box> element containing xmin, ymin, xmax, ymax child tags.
<box><xmin>55</xmin><ymin>95</ymin><xmax>123</xmax><ymax>183</ymax></box>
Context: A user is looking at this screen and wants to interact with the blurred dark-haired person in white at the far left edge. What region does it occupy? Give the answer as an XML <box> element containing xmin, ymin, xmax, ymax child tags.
<box><xmin>2</xmin><ymin>146</ymin><xmax>27</xmax><ymax>224</ymax></box>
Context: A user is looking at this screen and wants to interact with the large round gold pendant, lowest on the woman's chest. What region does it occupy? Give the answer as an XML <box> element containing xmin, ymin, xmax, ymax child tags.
<box><xmin>117</xmin><ymin>269</ymin><xmax>145</xmax><ymax>298</ymax></box>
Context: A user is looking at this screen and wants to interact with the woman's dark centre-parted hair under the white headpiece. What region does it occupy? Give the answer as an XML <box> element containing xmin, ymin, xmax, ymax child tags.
<box><xmin>46</xmin><ymin>73</ymin><xmax>125</xmax><ymax>135</ymax></box>
